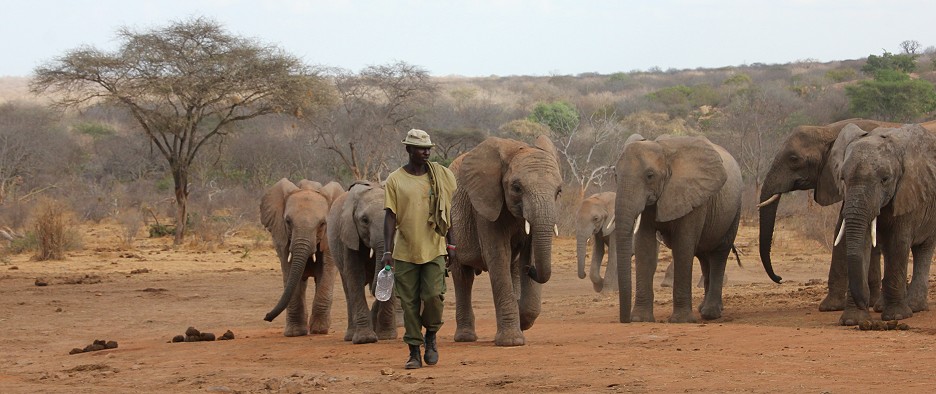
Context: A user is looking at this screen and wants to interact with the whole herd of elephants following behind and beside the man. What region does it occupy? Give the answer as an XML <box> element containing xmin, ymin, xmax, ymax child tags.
<box><xmin>252</xmin><ymin>119</ymin><xmax>936</xmax><ymax>346</ymax></box>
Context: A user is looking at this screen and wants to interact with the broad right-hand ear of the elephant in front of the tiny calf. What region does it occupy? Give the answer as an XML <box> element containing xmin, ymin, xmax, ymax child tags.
<box><xmin>657</xmin><ymin>137</ymin><xmax>728</xmax><ymax>222</ymax></box>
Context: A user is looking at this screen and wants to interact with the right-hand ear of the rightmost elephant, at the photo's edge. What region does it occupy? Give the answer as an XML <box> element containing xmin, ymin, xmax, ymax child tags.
<box><xmin>894</xmin><ymin>125</ymin><xmax>936</xmax><ymax>216</ymax></box>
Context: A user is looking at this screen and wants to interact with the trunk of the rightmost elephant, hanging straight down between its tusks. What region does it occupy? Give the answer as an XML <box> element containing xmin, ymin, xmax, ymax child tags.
<box><xmin>842</xmin><ymin>194</ymin><xmax>876</xmax><ymax>310</ymax></box>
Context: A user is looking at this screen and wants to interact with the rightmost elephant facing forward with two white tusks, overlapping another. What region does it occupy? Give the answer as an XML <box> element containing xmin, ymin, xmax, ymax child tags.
<box><xmin>830</xmin><ymin>125</ymin><xmax>936</xmax><ymax>325</ymax></box>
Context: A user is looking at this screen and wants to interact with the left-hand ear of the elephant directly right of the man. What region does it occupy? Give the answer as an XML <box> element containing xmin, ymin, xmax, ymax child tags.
<box><xmin>457</xmin><ymin>137</ymin><xmax>520</xmax><ymax>222</ymax></box>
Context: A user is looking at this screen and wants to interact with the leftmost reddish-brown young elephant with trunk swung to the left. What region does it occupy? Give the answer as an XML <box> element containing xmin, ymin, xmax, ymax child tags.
<box><xmin>260</xmin><ymin>178</ymin><xmax>344</xmax><ymax>337</ymax></box>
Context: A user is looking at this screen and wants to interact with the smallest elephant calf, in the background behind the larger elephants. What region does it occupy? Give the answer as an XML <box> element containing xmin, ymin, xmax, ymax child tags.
<box><xmin>575</xmin><ymin>192</ymin><xmax>617</xmax><ymax>293</ymax></box>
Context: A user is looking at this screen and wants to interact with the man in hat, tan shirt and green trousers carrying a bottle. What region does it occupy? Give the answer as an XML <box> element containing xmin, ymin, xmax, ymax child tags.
<box><xmin>382</xmin><ymin>129</ymin><xmax>455</xmax><ymax>369</ymax></box>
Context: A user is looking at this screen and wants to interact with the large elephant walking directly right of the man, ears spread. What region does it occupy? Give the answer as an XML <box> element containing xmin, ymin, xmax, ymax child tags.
<box><xmin>449</xmin><ymin>136</ymin><xmax>562</xmax><ymax>346</ymax></box>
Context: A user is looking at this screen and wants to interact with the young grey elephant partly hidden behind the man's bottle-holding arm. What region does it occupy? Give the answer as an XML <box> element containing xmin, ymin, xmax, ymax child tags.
<box><xmin>328</xmin><ymin>181</ymin><xmax>400</xmax><ymax>344</ymax></box>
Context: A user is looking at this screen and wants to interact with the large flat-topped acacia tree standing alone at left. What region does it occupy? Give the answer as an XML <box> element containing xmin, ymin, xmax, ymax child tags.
<box><xmin>30</xmin><ymin>18</ymin><xmax>327</xmax><ymax>244</ymax></box>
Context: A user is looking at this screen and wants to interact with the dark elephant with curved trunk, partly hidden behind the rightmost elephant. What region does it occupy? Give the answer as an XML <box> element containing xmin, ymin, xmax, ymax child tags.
<box><xmin>759</xmin><ymin>119</ymin><xmax>899</xmax><ymax>311</ymax></box>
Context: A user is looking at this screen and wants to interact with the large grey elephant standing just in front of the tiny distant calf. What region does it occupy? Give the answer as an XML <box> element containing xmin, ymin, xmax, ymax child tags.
<box><xmin>614</xmin><ymin>134</ymin><xmax>741</xmax><ymax>323</ymax></box>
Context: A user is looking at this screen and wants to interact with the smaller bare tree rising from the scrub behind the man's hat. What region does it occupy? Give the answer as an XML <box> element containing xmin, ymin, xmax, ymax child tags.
<box><xmin>312</xmin><ymin>62</ymin><xmax>437</xmax><ymax>180</ymax></box>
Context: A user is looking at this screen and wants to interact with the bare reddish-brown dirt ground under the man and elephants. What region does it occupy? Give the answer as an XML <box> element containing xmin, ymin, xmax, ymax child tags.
<box><xmin>0</xmin><ymin>224</ymin><xmax>936</xmax><ymax>393</ymax></box>
